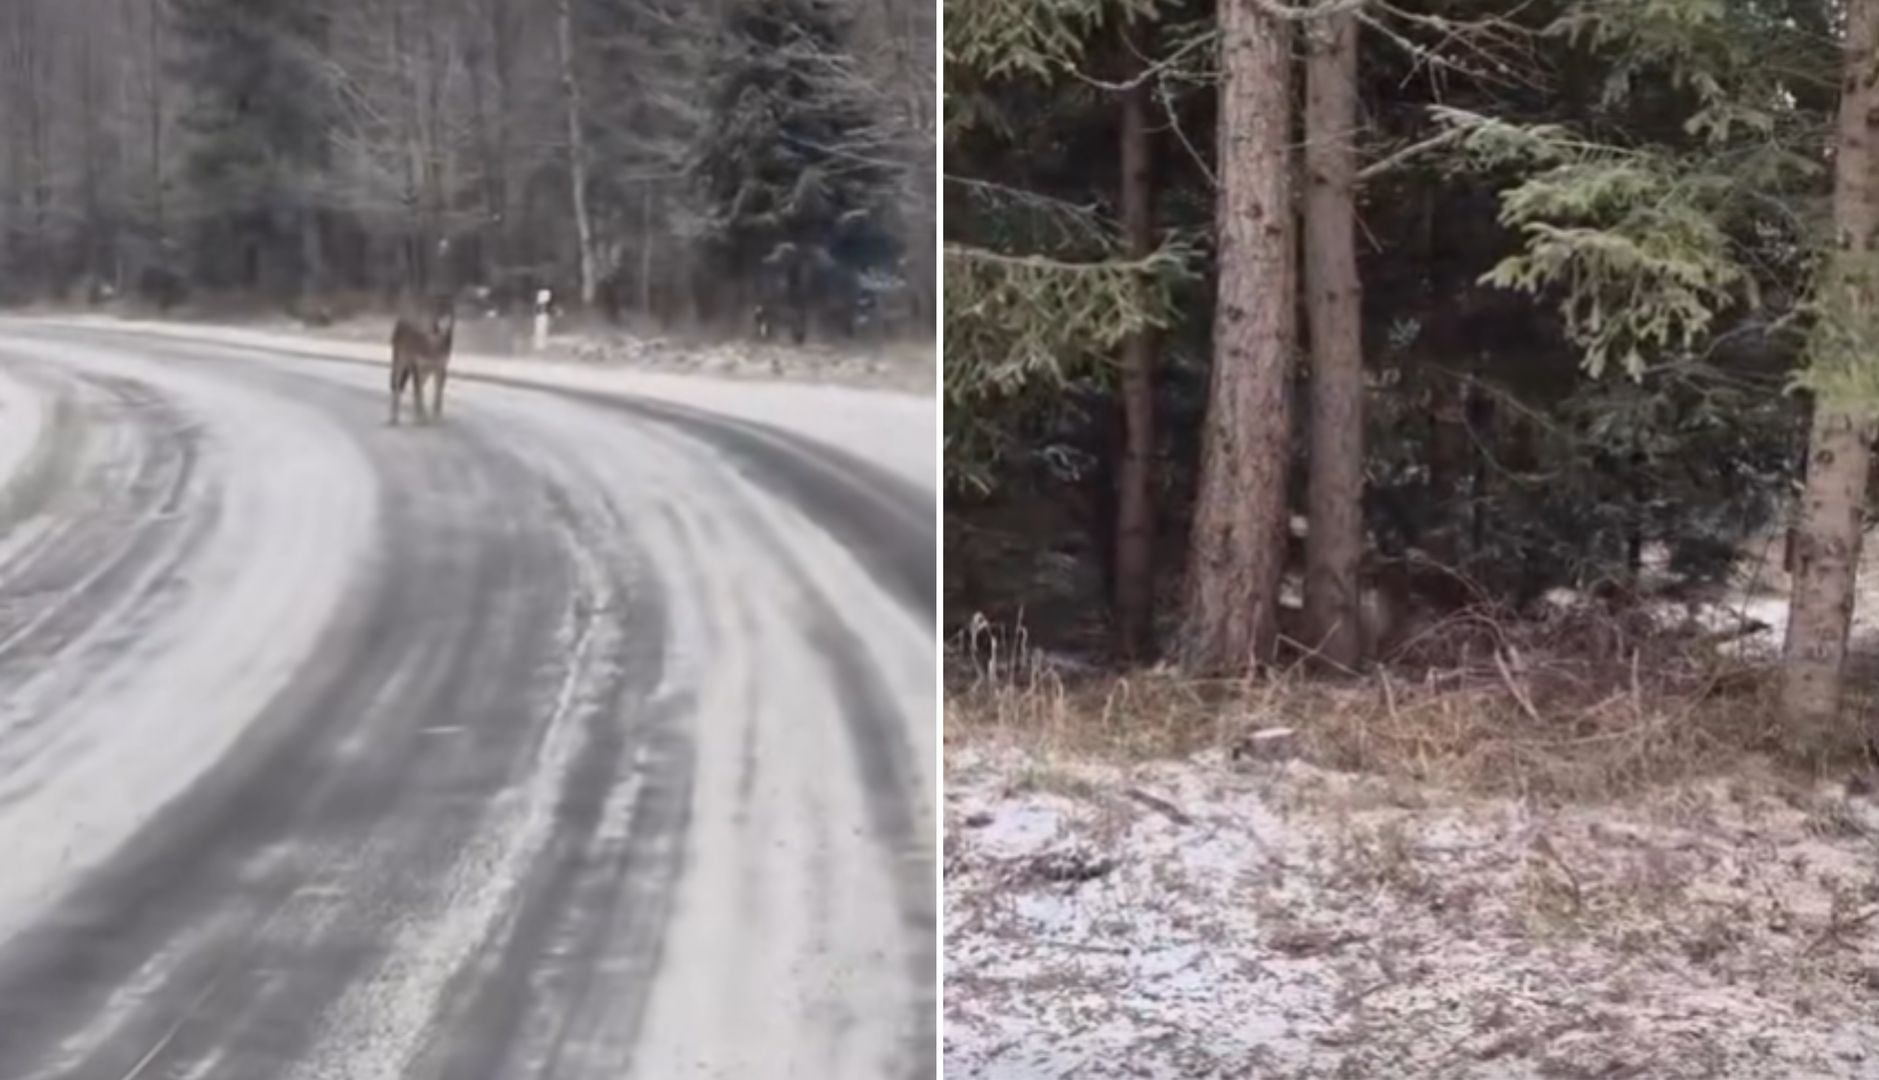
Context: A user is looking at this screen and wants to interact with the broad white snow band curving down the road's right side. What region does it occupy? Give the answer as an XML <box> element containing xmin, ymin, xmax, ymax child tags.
<box><xmin>449</xmin><ymin>379</ymin><xmax>936</xmax><ymax>1078</ymax></box>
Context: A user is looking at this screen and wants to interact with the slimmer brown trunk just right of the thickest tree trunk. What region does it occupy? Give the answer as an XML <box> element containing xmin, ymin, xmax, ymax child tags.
<box><xmin>1304</xmin><ymin>4</ymin><xmax>1364</xmax><ymax>669</ymax></box>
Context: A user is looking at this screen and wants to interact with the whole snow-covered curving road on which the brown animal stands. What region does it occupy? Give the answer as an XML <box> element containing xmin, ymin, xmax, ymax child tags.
<box><xmin>0</xmin><ymin>321</ymin><xmax>938</xmax><ymax>1080</ymax></box>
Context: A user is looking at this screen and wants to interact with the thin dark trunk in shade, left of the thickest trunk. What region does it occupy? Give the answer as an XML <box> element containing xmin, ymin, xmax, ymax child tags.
<box><xmin>1114</xmin><ymin>29</ymin><xmax>1156</xmax><ymax>661</ymax></box>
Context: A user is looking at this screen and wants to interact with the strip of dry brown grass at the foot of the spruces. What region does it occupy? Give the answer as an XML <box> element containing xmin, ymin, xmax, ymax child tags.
<box><xmin>945</xmin><ymin>612</ymin><xmax>1862</xmax><ymax>800</ymax></box>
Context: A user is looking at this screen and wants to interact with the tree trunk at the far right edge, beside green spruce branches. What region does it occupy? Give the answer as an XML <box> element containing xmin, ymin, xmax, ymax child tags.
<box><xmin>1781</xmin><ymin>0</ymin><xmax>1879</xmax><ymax>734</ymax></box>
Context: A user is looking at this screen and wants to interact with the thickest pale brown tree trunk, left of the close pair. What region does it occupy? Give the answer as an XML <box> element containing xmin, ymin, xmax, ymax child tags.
<box><xmin>1180</xmin><ymin>0</ymin><xmax>1298</xmax><ymax>672</ymax></box>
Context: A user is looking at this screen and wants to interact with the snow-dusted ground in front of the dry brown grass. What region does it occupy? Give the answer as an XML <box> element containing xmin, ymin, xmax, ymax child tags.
<box><xmin>943</xmin><ymin>738</ymin><xmax>1879</xmax><ymax>1080</ymax></box>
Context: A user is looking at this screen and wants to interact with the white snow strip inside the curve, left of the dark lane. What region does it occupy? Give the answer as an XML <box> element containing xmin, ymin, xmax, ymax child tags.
<box><xmin>0</xmin><ymin>339</ymin><xmax>372</xmax><ymax>961</ymax></box>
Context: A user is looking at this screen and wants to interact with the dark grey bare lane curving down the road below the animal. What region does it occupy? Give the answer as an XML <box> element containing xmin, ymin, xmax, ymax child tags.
<box><xmin>0</xmin><ymin>339</ymin><xmax>660</xmax><ymax>1076</ymax></box>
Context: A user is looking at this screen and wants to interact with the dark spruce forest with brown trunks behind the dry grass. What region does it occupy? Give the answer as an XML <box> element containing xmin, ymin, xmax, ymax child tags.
<box><xmin>943</xmin><ymin>0</ymin><xmax>1879</xmax><ymax>777</ymax></box>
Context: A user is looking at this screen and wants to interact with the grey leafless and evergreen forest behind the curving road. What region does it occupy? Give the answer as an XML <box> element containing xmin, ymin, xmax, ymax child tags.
<box><xmin>0</xmin><ymin>0</ymin><xmax>938</xmax><ymax>338</ymax></box>
